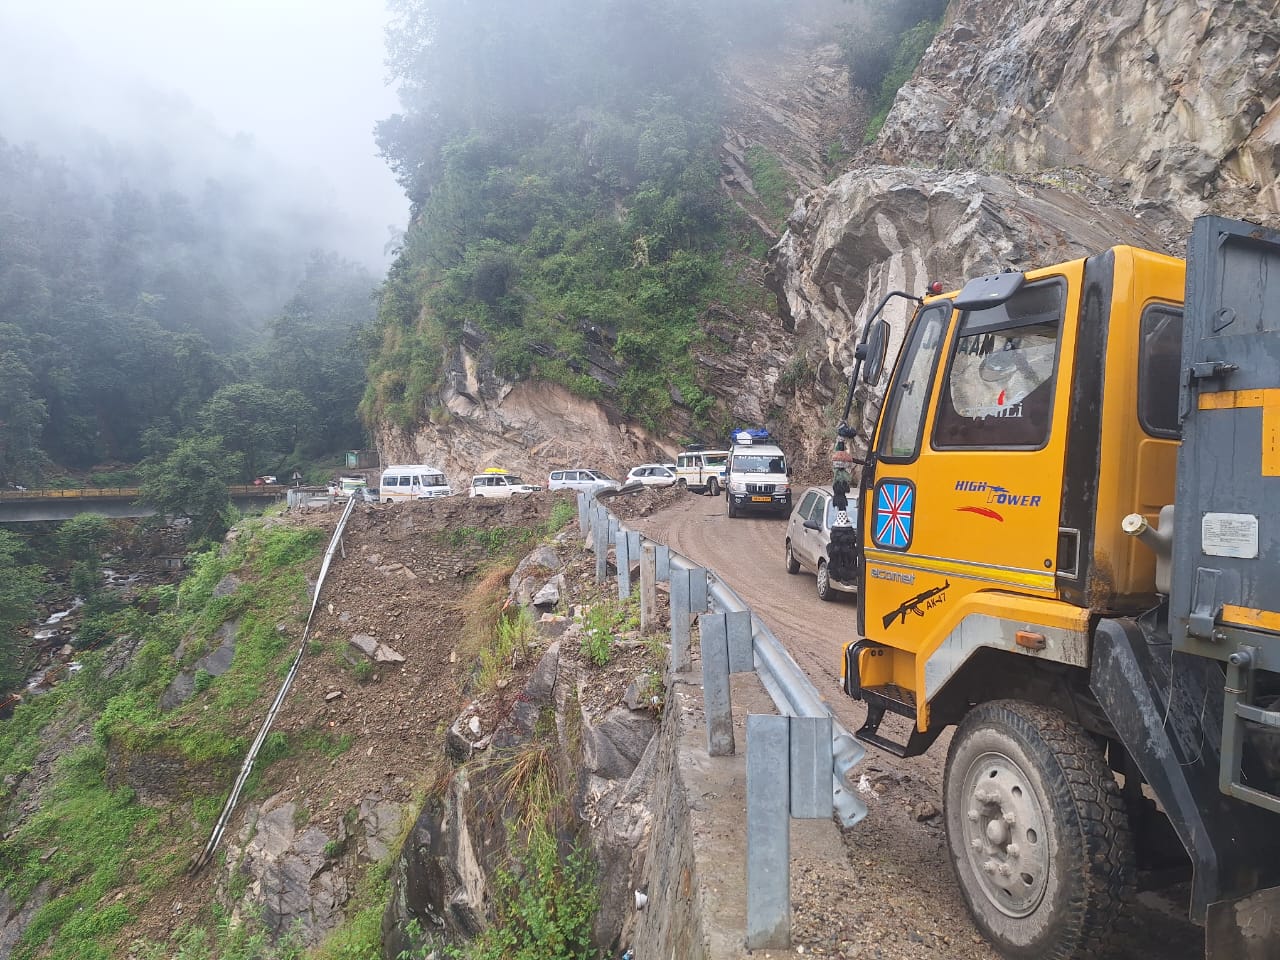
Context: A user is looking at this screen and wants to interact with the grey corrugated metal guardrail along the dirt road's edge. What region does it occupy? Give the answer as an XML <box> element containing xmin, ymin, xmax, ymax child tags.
<box><xmin>579</xmin><ymin>494</ymin><xmax>867</xmax><ymax>827</ymax></box>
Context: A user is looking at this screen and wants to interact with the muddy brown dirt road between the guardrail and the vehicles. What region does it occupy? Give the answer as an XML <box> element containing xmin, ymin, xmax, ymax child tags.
<box><xmin>627</xmin><ymin>495</ymin><xmax>1203</xmax><ymax>960</ymax></box>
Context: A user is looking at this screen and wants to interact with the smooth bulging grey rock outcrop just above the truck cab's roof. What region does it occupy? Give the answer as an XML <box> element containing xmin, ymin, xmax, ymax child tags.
<box><xmin>769</xmin><ymin>166</ymin><xmax>1188</xmax><ymax>458</ymax></box>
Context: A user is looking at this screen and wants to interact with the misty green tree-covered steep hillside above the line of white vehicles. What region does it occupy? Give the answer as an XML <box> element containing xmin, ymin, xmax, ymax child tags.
<box><xmin>361</xmin><ymin>0</ymin><xmax>785</xmax><ymax>429</ymax></box>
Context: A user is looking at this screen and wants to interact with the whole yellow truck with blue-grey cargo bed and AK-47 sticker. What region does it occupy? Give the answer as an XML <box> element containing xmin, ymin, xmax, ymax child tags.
<box><xmin>832</xmin><ymin>218</ymin><xmax>1280</xmax><ymax>960</ymax></box>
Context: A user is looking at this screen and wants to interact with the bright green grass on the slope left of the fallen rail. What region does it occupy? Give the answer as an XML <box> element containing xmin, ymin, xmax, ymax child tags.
<box><xmin>0</xmin><ymin>521</ymin><xmax>325</xmax><ymax>960</ymax></box>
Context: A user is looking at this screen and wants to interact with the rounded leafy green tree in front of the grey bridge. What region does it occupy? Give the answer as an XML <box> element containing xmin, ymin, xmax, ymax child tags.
<box><xmin>138</xmin><ymin>436</ymin><xmax>243</xmax><ymax>539</ymax></box>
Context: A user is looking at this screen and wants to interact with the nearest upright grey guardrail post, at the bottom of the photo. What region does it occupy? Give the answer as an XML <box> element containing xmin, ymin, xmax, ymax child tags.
<box><xmin>746</xmin><ymin>714</ymin><xmax>791</xmax><ymax>950</ymax></box>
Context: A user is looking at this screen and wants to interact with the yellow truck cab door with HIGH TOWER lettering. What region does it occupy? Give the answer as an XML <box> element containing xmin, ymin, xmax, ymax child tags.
<box><xmin>861</xmin><ymin>275</ymin><xmax>1074</xmax><ymax>660</ymax></box>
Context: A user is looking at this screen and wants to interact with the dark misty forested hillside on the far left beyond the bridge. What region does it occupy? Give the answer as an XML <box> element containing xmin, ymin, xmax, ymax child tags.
<box><xmin>0</xmin><ymin>140</ymin><xmax>375</xmax><ymax>485</ymax></box>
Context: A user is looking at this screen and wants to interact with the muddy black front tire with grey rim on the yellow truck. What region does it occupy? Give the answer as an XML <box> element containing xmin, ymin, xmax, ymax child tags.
<box><xmin>943</xmin><ymin>700</ymin><xmax>1135</xmax><ymax>960</ymax></box>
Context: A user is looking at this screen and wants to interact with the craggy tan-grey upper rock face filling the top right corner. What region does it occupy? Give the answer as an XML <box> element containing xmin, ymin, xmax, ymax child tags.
<box><xmin>876</xmin><ymin>0</ymin><xmax>1280</xmax><ymax>225</ymax></box>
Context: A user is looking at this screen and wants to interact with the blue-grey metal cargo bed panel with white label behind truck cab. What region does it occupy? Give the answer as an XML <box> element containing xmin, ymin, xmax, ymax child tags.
<box><xmin>1170</xmin><ymin>216</ymin><xmax>1280</xmax><ymax>655</ymax></box>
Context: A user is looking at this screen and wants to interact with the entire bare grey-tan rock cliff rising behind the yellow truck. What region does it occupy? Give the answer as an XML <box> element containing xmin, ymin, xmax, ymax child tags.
<box><xmin>768</xmin><ymin>0</ymin><xmax>1280</xmax><ymax>462</ymax></box>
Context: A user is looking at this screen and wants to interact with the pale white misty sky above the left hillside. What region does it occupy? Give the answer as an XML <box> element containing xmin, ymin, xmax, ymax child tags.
<box><xmin>0</xmin><ymin>0</ymin><xmax>408</xmax><ymax>268</ymax></box>
